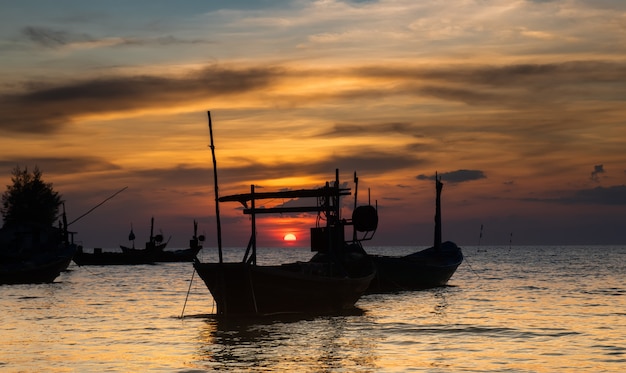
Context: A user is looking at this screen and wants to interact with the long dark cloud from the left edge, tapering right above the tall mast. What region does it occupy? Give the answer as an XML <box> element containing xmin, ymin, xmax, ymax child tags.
<box><xmin>0</xmin><ymin>66</ymin><xmax>281</xmax><ymax>134</ymax></box>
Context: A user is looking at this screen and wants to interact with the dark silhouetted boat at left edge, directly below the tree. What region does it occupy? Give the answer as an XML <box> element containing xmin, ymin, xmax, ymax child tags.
<box><xmin>0</xmin><ymin>213</ymin><xmax>76</xmax><ymax>284</ymax></box>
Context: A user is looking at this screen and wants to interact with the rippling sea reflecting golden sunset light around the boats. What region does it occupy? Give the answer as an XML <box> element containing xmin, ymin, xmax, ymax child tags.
<box><xmin>0</xmin><ymin>245</ymin><xmax>626</xmax><ymax>373</ymax></box>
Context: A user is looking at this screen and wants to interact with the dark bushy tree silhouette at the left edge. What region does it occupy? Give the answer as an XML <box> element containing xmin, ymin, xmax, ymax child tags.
<box><xmin>0</xmin><ymin>166</ymin><xmax>62</xmax><ymax>227</ymax></box>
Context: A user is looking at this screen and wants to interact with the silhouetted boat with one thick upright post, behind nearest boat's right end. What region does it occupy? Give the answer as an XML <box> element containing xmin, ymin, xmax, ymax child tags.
<box><xmin>367</xmin><ymin>176</ymin><xmax>463</xmax><ymax>293</ymax></box>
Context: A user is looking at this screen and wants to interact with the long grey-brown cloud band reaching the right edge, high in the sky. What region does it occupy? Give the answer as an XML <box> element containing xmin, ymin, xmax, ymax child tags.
<box><xmin>356</xmin><ymin>61</ymin><xmax>626</xmax><ymax>107</ymax></box>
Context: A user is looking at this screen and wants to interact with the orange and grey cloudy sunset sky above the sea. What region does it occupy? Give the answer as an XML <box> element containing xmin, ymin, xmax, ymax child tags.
<box><xmin>0</xmin><ymin>0</ymin><xmax>626</xmax><ymax>248</ymax></box>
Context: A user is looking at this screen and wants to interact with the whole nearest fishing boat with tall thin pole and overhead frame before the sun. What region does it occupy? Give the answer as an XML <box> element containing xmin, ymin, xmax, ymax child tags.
<box><xmin>194</xmin><ymin>115</ymin><xmax>377</xmax><ymax>315</ymax></box>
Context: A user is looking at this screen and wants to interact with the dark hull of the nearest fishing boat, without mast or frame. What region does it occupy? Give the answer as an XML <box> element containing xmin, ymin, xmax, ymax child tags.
<box><xmin>194</xmin><ymin>261</ymin><xmax>374</xmax><ymax>315</ymax></box>
